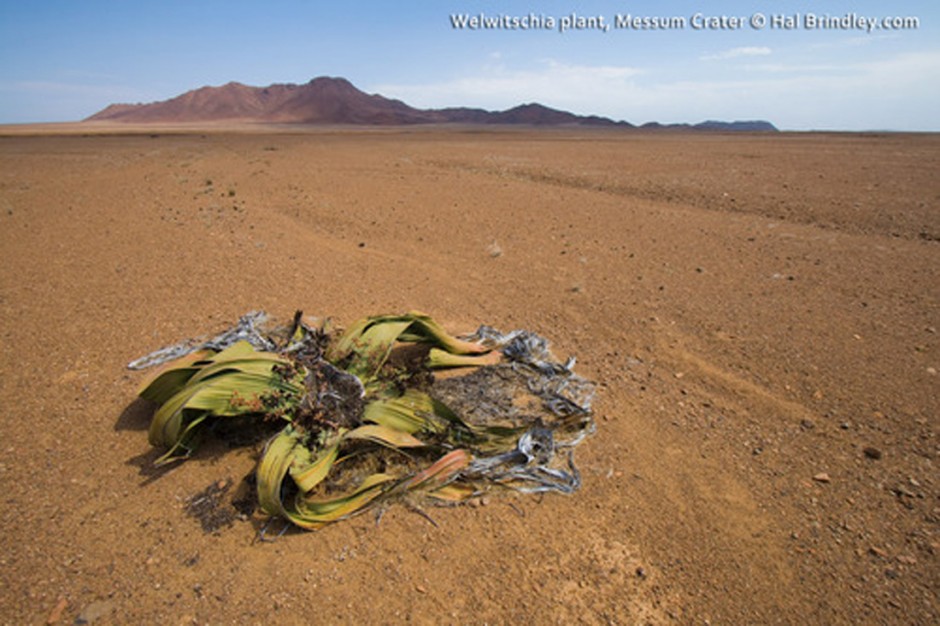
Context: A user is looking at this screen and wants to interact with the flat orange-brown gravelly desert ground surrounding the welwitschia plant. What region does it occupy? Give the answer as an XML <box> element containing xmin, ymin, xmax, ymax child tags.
<box><xmin>0</xmin><ymin>124</ymin><xmax>940</xmax><ymax>624</ymax></box>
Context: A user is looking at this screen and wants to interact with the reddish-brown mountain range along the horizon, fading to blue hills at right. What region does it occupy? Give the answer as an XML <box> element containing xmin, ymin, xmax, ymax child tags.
<box><xmin>86</xmin><ymin>76</ymin><xmax>776</xmax><ymax>130</ymax></box>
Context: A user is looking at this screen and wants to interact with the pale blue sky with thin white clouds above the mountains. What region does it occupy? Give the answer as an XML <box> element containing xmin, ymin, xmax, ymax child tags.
<box><xmin>0</xmin><ymin>0</ymin><xmax>940</xmax><ymax>131</ymax></box>
